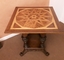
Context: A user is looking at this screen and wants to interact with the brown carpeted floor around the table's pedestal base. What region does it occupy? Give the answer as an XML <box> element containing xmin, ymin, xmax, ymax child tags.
<box><xmin>0</xmin><ymin>34</ymin><xmax>64</xmax><ymax>60</ymax></box>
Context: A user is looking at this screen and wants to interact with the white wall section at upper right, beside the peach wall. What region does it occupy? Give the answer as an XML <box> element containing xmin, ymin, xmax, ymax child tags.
<box><xmin>49</xmin><ymin>0</ymin><xmax>64</xmax><ymax>23</ymax></box>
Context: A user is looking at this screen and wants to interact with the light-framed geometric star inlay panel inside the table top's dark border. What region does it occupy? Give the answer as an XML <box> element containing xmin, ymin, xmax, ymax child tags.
<box><xmin>10</xmin><ymin>8</ymin><xmax>58</xmax><ymax>30</ymax></box>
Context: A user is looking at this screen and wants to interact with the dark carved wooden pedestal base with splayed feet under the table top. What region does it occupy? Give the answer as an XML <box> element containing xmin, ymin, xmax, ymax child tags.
<box><xmin>20</xmin><ymin>34</ymin><xmax>49</xmax><ymax>56</ymax></box>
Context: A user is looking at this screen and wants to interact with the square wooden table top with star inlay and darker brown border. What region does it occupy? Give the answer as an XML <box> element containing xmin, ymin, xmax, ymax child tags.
<box><xmin>5</xmin><ymin>7</ymin><xmax>59</xmax><ymax>33</ymax></box>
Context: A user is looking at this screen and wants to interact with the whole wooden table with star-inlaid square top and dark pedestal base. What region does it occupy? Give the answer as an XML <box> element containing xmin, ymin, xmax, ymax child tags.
<box><xmin>5</xmin><ymin>7</ymin><xmax>60</xmax><ymax>56</ymax></box>
